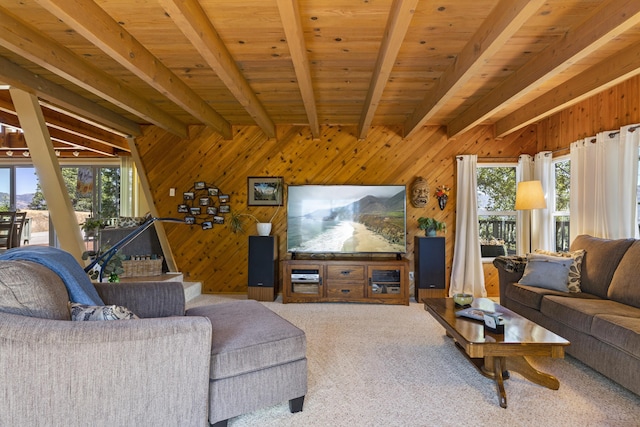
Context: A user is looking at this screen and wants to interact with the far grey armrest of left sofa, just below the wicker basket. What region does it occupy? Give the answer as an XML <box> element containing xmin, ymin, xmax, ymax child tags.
<box><xmin>95</xmin><ymin>282</ymin><xmax>185</xmax><ymax>318</ymax></box>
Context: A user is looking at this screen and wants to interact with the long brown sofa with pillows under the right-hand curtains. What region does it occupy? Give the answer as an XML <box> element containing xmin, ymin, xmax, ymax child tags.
<box><xmin>493</xmin><ymin>235</ymin><xmax>640</xmax><ymax>394</ymax></box>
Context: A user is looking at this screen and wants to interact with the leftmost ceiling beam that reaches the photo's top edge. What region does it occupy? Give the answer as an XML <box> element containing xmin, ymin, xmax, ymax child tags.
<box><xmin>37</xmin><ymin>0</ymin><xmax>232</xmax><ymax>139</ymax></box>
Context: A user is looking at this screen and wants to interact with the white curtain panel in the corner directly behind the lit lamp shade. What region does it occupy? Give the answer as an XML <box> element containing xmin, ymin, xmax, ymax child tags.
<box><xmin>531</xmin><ymin>151</ymin><xmax>555</xmax><ymax>251</ymax></box>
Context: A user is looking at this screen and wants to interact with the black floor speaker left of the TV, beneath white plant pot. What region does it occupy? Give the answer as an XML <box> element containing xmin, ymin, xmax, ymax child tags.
<box><xmin>248</xmin><ymin>236</ymin><xmax>278</xmax><ymax>288</ymax></box>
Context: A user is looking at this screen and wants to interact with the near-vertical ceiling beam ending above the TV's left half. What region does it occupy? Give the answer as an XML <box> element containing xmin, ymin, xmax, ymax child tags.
<box><xmin>278</xmin><ymin>0</ymin><xmax>320</xmax><ymax>138</ymax></box>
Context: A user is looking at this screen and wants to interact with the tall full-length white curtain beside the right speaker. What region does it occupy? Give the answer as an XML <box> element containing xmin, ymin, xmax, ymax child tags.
<box><xmin>449</xmin><ymin>155</ymin><xmax>487</xmax><ymax>297</ymax></box>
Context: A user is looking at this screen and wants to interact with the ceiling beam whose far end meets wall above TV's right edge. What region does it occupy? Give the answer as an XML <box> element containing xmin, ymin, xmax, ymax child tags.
<box><xmin>404</xmin><ymin>0</ymin><xmax>544</xmax><ymax>137</ymax></box>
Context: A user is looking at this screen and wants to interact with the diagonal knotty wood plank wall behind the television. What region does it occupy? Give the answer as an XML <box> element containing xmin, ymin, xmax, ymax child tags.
<box><xmin>136</xmin><ymin>126</ymin><xmax>536</xmax><ymax>295</ymax></box>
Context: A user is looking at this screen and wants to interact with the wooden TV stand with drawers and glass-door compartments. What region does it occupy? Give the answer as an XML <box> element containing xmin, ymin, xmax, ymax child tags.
<box><xmin>282</xmin><ymin>258</ymin><xmax>409</xmax><ymax>305</ymax></box>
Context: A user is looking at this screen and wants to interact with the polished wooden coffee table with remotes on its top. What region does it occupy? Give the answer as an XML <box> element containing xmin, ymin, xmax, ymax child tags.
<box><xmin>422</xmin><ymin>298</ymin><xmax>570</xmax><ymax>408</ymax></box>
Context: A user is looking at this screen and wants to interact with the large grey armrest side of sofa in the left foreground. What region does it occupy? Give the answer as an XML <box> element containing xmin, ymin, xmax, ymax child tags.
<box><xmin>0</xmin><ymin>313</ymin><xmax>211</xmax><ymax>426</ymax></box>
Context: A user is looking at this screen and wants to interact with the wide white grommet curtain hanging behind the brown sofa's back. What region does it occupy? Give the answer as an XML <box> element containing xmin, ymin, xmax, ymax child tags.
<box><xmin>570</xmin><ymin>126</ymin><xmax>638</xmax><ymax>241</ymax></box>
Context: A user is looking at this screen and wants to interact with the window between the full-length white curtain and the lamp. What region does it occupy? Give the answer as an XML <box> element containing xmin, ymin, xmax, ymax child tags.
<box><xmin>478</xmin><ymin>164</ymin><xmax>517</xmax><ymax>257</ymax></box>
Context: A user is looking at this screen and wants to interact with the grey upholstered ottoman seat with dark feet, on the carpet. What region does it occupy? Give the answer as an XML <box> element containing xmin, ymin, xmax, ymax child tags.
<box><xmin>186</xmin><ymin>300</ymin><xmax>307</xmax><ymax>427</ymax></box>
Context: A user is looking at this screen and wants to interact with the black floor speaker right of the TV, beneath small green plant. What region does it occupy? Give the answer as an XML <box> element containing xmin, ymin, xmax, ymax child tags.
<box><xmin>413</xmin><ymin>236</ymin><xmax>446</xmax><ymax>289</ymax></box>
